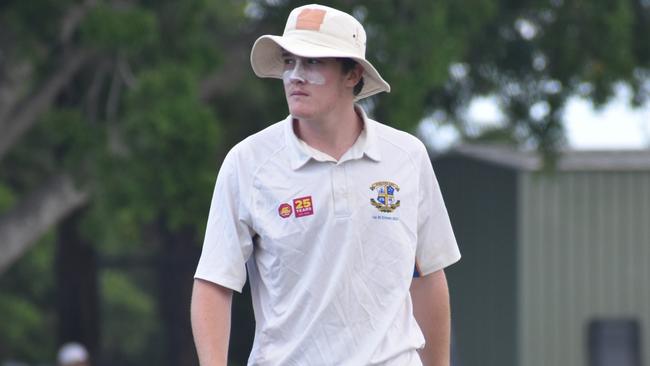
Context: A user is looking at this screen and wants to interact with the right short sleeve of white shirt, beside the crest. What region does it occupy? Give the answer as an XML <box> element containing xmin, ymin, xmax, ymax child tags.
<box><xmin>415</xmin><ymin>146</ymin><xmax>460</xmax><ymax>276</ymax></box>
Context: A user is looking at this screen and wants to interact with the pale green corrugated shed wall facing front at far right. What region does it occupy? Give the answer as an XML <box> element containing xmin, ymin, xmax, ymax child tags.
<box><xmin>518</xmin><ymin>172</ymin><xmax>650</xmax><ymax>366</ymax></box>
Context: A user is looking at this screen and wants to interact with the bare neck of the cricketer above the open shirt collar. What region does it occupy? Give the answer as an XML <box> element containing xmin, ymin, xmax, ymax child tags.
<box><xmin>293</xmin><ymin>105</ymin><xmax>363</xmax><ymax>160</ymax></box>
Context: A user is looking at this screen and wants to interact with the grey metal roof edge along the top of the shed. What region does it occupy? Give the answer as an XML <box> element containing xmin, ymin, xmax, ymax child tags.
<box><xmin>435</xmin><ymin>145</ymin><xmax>650</xmax><ymax>171</ymax></box>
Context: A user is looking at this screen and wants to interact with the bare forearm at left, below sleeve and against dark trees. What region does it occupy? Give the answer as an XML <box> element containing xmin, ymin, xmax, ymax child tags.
<box><xmin>191</xmin><ymin>280</ymin><xmax>232</xmax><ymax>366</ymax></box>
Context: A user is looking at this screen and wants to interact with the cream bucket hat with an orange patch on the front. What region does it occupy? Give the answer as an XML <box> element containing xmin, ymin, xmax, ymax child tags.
<box><xmin>251</xmin><ymin>4</ymin><xmax>390</xmax><ymax>100</ymax></box>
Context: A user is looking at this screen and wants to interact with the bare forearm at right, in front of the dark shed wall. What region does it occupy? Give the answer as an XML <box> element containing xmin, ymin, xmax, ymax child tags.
<box><xmin>411</xmin><ymin>270</ymin><xmax>451</xmax><ymax>366</ymax></box>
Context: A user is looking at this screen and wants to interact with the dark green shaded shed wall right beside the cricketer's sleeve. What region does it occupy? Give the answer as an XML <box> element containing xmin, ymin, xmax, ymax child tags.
<box><xmin>433</xmin><ymin>157</ymin><xmax>517</xmax><ymax>366</ymax></box>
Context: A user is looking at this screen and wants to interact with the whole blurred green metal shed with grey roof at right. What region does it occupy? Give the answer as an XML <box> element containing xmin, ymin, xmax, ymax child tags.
<box><xmin>433</xmin><ymin>145</ymin><xmax>650</xmax><ymax>366</ymax></box>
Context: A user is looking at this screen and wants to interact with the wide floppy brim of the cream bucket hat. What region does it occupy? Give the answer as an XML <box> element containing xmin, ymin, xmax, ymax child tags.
<box><xmin>251</xmin><ymin>35</ymin><xmax>390</xmax><ymax>100</ymax></box>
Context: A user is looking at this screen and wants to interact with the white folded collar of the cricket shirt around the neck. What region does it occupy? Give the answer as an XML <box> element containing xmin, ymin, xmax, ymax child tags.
<box><xmin>283</xmin><ymin>105</ymin><xmax>381</xmax><ymax>170</ymax></box>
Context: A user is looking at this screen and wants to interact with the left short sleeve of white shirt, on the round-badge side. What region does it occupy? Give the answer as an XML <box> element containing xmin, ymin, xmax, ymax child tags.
<box><xmin>194</xmin><ymin>150</ymin><xmax>254</xmax><ymax>292</ymax></box>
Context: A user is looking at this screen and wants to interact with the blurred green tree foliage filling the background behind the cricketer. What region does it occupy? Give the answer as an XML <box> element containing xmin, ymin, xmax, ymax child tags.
<box><xmin>0</xmin><ymin>0</ymin><xmax>650</xmax><ymax>363</ymax></box>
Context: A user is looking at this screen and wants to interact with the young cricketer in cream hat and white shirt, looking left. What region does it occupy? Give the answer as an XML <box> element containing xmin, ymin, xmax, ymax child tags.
<box><xmin>191</xmin><ymin>5</ymin><xmax>460</xmax><ymax>366</ymax></box>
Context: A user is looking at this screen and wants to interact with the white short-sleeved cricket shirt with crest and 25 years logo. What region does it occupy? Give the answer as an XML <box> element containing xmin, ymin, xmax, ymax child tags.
<box><xmin>195</xmin><ymin>107</ymin><xmax>460</xmax><ymax>366</ymax></box>
